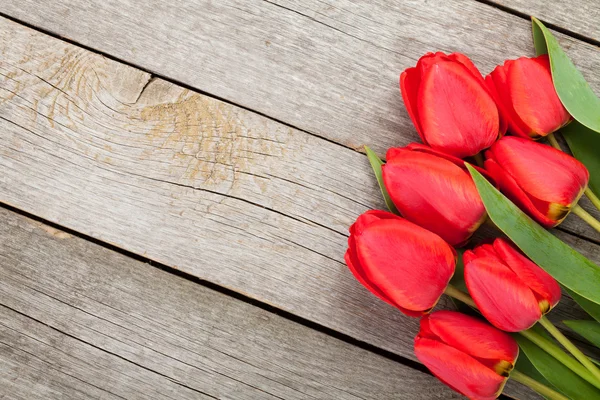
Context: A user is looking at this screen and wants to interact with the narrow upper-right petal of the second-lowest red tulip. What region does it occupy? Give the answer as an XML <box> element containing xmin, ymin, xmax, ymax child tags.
<box><xmin>494</xmin><ymin>239</ymin><xmax>561</xmax><ymax>307</ymax></box>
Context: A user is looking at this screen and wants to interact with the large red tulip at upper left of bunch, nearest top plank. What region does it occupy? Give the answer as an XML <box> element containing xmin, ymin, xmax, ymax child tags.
<box><xmin>400</xmin><ymin>53</ymin><xmax>506</xmax><ymax>158</ymax></box>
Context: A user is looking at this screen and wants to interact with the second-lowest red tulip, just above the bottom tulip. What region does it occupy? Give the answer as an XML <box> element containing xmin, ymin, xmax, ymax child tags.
<box><xmin>463</xmin><ymin>239</ymin><xmax>561</xmax><ymax>332</ymax></box>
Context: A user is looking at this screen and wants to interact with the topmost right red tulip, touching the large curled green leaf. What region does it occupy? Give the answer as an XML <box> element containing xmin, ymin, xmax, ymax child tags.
<box><xmin>485</xmin><ymin>55</ymin><xmax>571</xmax><ymax>139</ymax></box>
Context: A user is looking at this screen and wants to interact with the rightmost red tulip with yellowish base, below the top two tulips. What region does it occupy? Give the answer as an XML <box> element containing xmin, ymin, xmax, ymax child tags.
<box><xmin>485</xmin><ymin>136</ymin><xmax>589</xmax><ymax>228</ymax></box>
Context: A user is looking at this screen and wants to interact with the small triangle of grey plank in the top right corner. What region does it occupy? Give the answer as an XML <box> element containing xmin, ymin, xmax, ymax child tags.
<box><xmin>494</xmin><ymin>0</ymin><xmax>600</xmax><ymax>42</ymax></box>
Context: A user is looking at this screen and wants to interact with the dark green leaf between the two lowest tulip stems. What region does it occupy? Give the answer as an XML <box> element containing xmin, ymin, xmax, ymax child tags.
<box><xmin>514</xmin><ymin>335</ymin><xmax>600</xmax><ymax>400</ymax></box>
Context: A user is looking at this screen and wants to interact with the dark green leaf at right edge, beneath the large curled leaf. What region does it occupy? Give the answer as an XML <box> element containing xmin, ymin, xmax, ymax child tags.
<box><xmin>560</xmin><ymin>121</ymin><xmax>600</xmax><ymax>194</ymax></box>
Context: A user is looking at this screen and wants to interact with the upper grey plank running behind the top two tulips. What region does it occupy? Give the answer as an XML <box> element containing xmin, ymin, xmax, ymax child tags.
<box><xmin>0</xmin><ymin>0</ymin><xmax>600</xmax><ymax>242</ymax></box>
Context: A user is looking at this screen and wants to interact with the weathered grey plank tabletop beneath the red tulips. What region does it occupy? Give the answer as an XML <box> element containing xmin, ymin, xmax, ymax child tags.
<box><xmin>0</xmin><ymin>0</ymin><xmax>600</xmax><ymax>400</ymax></box>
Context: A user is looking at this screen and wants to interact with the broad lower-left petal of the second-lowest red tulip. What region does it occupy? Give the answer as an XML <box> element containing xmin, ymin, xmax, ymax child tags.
<box><xmin>465</xmin><ymin>250</ymin><xmax>542</xmax><ymax>332</ymax></box>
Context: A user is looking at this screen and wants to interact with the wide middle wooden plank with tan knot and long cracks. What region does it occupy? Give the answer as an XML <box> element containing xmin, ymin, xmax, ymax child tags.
<box><xmin>0</xmin><ymin>13</ymin><xmax>600</xmax><ymax>378</ymax></box>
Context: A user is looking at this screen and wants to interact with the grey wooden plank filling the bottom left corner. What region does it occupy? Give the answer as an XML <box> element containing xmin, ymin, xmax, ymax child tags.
<box><xmin>0</xmin><ymin>209</ymin><xmax>460</xmax><ymax>400</ymax></box>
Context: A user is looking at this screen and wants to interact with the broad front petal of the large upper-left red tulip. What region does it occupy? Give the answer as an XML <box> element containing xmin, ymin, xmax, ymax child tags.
<box><xmin>417</xmin><ymin>60</ymin><xmax>500</xmax><ymax>158</ymax></box>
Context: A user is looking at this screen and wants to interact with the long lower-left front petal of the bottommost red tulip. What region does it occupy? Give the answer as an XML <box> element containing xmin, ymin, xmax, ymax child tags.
<box><xmin>415</xmin><ymin>337</ymin><xmax>507</xmax><ymax>400</ymax></box>
